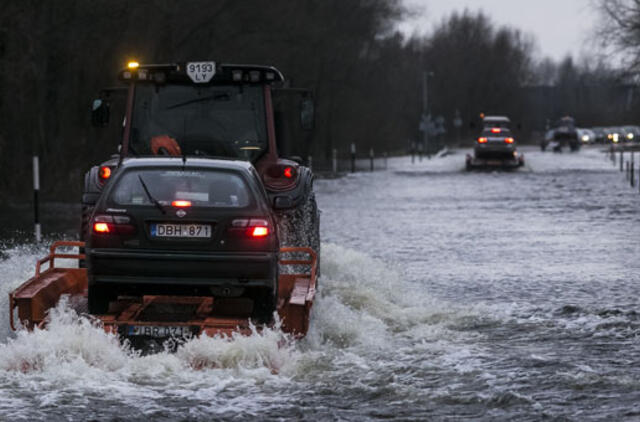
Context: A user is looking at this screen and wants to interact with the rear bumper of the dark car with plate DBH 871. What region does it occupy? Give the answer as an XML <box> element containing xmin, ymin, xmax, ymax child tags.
<box><xmin>87</xmin><ymin>249</ymin><xmax>278</xmax><ymax>287</ymax></box>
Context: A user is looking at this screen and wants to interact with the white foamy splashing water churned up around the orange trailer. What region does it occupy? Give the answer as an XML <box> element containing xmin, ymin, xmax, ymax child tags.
<box><xmin>0</xmin><ymin>239</ymin><xmax>480</xmax><ymax>419</ymax></box>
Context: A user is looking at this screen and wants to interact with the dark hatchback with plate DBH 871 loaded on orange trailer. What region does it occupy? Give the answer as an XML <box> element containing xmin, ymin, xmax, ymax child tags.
<box><xmin>86</xmin><ymin>157</ymin><xmax>279</xmax><ymax>323</ymax></box>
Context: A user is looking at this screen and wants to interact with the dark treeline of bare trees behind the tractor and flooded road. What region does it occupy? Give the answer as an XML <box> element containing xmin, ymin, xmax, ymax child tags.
<box><xmin>0</xmin><ymin>0</ymin><xmax>636</xmax><ymax>200</ymax></box>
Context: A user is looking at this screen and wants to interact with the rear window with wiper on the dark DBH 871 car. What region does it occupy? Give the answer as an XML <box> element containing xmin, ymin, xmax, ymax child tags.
<box><xmin>110</xmin><ymin>169</ymin><xmax>252</xmax><ymax>208</ymax></box>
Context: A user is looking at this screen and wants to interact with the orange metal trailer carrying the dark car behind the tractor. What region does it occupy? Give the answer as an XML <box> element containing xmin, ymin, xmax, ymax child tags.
<box><xmin>9</xmin><ymin>241</ymin><xmax>317</xmax><ymax>345</ymax></box>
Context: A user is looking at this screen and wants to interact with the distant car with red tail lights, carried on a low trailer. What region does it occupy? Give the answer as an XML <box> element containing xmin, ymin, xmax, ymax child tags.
<box><xmin>466</xmin><ymin>126</ymin><xmax>524</xmax><ymax>170</ymax></box>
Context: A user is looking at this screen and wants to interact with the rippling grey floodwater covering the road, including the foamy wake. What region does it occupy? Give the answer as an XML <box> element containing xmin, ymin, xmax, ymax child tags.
<box><xmin>0</xmin><ymin>149</ymin><xmax>640</xmax><ymax>421</ymax></box>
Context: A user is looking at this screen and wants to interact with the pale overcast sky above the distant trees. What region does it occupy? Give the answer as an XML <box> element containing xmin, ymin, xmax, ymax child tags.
<box><xmin>401</xmin><ymin>0</ymin><xmax>598</xmax><ymax>59</ymax></box>
